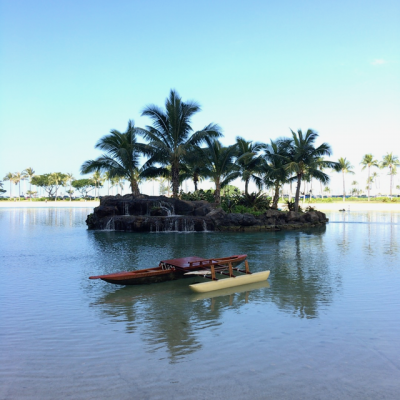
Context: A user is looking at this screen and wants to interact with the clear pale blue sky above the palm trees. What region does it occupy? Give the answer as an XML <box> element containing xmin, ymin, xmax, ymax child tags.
<box><xmin>0</xmin><ymin>0</ymin><xmax>400</xmax><ymax>197</ymax></box>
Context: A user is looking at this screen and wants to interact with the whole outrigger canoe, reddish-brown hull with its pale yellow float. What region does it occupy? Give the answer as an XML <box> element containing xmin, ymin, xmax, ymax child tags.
<box><xmin>89</xmin><ymin>254</ymin><xmax>269</xmax><ymax>293</ymax></box>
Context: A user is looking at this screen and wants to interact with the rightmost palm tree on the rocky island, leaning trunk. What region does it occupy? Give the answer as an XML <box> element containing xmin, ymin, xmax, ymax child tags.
<box><xmin>285</xmin><ymin>129</ymin><xmax>336</xmax><ymax>212</ymax></box>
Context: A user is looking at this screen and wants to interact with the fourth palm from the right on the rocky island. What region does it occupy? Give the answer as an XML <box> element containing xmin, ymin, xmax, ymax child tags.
<box><xmin>195</xmin><ymin>137</ymin><xmax>239</xmax><ymax>204</ymax></box>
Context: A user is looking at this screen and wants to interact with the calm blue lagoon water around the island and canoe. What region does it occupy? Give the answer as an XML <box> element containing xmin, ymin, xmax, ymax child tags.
<box><xmin>0</xmin><ymin>208</ymin><xmax>400</xmax><ymax>400</ymax></box>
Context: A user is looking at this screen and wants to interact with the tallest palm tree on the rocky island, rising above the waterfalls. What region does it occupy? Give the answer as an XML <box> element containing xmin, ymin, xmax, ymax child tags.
<box><xmin>142</xmin><ymin>90</ymin><xmax>221</xmax><ymax>197</ymax></box>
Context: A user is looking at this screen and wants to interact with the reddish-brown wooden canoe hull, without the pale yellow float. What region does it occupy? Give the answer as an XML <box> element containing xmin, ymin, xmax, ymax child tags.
<box><xmin>89</xmin><ymin>254</ymin><xmax>247</xmax><ymax>285</ymax></box>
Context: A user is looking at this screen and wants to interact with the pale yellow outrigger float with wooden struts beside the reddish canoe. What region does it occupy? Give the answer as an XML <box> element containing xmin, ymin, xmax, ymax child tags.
<box><xmin>186</xmin><ymin>261</ymin><xmax>270</xmax><ymax>293</ymax></box>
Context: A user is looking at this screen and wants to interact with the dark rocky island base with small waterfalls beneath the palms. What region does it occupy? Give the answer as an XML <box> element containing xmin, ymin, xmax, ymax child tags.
<box><xmin>86</xmin><ymin>195</ymin><xmax>328</xmax><ymax>232</ymax></box>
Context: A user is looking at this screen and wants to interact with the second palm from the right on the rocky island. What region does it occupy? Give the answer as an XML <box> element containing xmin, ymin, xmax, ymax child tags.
<box><xmin>260</xmin><ymin>140</ymin><xmax>290</xmax><ymax>208</ymax></box>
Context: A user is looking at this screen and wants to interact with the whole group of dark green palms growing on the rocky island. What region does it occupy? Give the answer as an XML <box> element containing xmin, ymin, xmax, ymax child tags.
<box><xmin>81</xmin><ymin>90</ymin><xmax>337</xmax><ymax>211</ymax></box>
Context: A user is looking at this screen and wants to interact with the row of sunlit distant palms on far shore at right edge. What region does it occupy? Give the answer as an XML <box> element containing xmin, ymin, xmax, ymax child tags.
<box><xmin>335</xmin><ymin>153</ymin><xmax>400</xmax><ymax>201</ymax></box>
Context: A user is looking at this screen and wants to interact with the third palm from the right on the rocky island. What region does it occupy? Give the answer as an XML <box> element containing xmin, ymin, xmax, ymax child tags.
<box><xmin>236</xmin><ymin>136</ymin><xmax>265</xmax><ymax>195</ymax></box>
